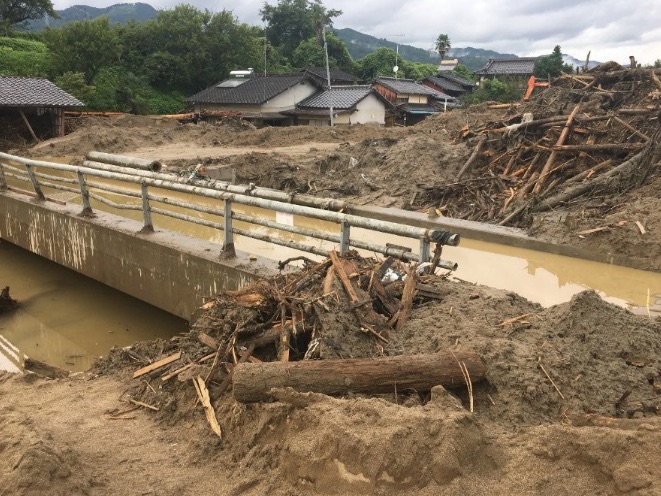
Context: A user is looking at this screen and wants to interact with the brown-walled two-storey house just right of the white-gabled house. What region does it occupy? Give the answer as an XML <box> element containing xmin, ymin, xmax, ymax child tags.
<box><xmin>374</xmin><ymin>77</ymin><xmax>456</xmax><ymax>126</ymax></box>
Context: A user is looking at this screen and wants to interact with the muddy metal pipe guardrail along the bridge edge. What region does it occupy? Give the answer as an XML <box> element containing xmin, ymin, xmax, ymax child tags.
<box><xmin>0</xmin><ymin>153</ymin><xmax>460</xmax><ymax>270</ymax></box>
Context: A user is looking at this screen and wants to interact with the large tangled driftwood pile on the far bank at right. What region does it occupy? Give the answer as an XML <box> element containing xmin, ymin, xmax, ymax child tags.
<box><xmin>417</xmin><ymin>64</ymin><xmax>661</xmax><ymax>226</ymax></box>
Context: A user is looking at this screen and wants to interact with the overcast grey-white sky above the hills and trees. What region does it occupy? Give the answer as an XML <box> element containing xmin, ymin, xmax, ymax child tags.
<box><xmin>54</xmin><ymin>0</ymin><xmax>661</xmax><ymax>64</ymax></box>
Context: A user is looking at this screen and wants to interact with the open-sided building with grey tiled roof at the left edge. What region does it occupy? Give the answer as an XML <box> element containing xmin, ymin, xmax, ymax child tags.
<box><xmin>0</xmin><ymin>76</ymin><xmax>85</xmax><ymax>141</ymax></box>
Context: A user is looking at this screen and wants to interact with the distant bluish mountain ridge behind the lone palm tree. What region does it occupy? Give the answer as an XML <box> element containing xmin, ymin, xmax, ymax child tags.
<box><xmin>334</xmin><ymin>28</ymin><xmax>516</xmax><ymax>71</ymax></box>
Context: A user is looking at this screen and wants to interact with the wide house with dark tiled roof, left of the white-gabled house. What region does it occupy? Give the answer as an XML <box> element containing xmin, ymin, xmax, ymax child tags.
<box><xmin>186</xmin><ymin>72</ymin><xmax>320</xmax><ymax>126</ymax></box>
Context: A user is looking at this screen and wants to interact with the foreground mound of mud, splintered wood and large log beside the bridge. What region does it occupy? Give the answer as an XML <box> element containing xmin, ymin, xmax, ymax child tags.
<box><xmin>93</xmin><ymin>252</ymin><xmax>661</xmax><ymax>442</ymax></box>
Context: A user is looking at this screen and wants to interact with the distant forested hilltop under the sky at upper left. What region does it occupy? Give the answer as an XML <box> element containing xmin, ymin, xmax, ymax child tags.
<box><xmin>23</xmin><ymin>3</ymin><xmax>158</xmax><ymax>31</ymax></box>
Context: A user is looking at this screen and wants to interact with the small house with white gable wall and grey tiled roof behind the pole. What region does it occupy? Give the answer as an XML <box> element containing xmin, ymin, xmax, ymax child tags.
<box><xmin>283</xmin><ymin>85</ymin><xmax>392</xmax><ymax>126</ymax></box>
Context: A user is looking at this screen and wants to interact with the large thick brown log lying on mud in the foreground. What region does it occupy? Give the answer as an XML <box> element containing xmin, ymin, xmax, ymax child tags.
<box><xmin>233</xmin><ymin>351</ymin><xmax>486</xmax><ymax>403</ymax></box>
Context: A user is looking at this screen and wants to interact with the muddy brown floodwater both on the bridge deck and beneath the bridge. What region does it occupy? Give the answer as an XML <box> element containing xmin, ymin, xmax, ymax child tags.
<box><xmin>0</xmin><ymin>165</ymin><xmax>661</xmax><ymax>370</ymax></box>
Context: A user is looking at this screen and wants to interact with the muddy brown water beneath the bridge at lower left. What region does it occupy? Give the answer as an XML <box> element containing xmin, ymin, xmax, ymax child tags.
<box><xmin>0</xmin><ymin>241</ymin><xmax>187</xmax><ymax>371</ymax></box>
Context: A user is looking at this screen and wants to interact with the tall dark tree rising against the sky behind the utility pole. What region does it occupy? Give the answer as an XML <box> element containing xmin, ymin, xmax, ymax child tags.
<box><xmin>259</xmin><ymin>0</ymin><xmax>342</xmax><ymax>58</ymax></box>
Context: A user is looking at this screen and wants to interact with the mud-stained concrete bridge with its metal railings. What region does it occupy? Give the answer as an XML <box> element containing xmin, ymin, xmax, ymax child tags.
<box><xmin>0</xmin><ymin>153</ymin><xmax>626</xmax><ymax>319</ymax></box>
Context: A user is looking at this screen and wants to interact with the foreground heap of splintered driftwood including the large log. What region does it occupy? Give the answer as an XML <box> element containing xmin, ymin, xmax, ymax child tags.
<box><xmin>123</xmin><ymin>252</ymin><xmax>486</xmax><ymax>435</ymax></box>
